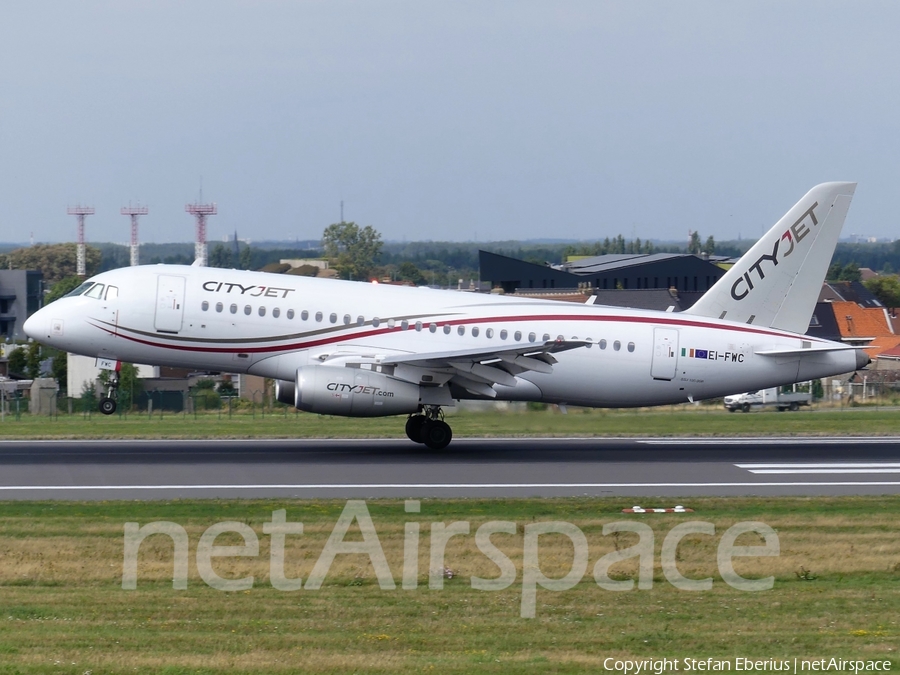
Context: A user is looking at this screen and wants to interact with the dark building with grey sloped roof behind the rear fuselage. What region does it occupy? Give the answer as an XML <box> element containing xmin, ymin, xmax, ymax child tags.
<box><xmin>478</xmin><ymin>251</ymin><xmax>731</xmax><ymax>293</ymax></box>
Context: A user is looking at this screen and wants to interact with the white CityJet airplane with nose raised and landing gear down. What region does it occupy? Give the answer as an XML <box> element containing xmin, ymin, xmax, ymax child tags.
<box><xmin>24</xmin><ymin>182</ymin><xmax>869</xmax><ymax>450</ymax></box>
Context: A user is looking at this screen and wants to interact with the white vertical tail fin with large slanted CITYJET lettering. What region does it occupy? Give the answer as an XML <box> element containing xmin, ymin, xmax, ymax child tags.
<box><xmin>684</xmin><ymin>183</ymin><xmax>856</xmax><ymax>333</ymax></box>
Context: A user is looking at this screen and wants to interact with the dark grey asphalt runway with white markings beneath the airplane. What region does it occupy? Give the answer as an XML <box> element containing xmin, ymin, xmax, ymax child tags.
<box><xmin>0</xmin><ymin>437</ymin><xmax>900</xmax><ymax>504</ymax></box>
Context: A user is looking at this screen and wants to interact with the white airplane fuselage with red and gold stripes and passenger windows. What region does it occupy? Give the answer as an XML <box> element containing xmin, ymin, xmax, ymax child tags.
<box><xmin>26</xmin><ymin>265</ymin><xmax>860</xmax><ymax>407</ymax></box>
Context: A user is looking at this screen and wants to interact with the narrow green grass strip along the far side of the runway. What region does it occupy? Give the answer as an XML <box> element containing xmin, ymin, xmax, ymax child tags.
<box><xmin>0</xmin><ymin>406</ymin><xmax>900</xmax><ymax>439</ymax></box>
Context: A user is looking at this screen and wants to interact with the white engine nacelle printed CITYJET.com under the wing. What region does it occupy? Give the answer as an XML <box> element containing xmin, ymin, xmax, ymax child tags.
<box><xmin>294</xmin><ymin>366</ymin><xmax>419</xmax><ymax>417</ymax></box>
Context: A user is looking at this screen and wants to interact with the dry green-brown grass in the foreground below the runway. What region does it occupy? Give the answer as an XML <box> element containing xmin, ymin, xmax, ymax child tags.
<box><xmin>0</xmin><ymin>496</ymin><xmax>900</xmax><ymax>675</ymax></box>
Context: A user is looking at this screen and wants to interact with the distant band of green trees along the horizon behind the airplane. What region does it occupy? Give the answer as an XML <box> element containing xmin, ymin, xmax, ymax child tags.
<box><xmin>0</xmin><ymin>231</ymin><xmax>900</xmax><ymax>302</ymax></box>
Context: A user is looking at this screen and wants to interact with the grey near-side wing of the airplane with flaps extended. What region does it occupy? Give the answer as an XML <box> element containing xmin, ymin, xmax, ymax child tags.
<box><xmin>326</xmin><ymin>340</ymin><xmax>590</xmax><ymax>398</ymax></box>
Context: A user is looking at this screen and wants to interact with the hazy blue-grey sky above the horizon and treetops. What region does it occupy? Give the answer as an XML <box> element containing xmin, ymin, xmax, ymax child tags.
<box><xmin>0</xmin><ymin>0</ymin><xmax>900</xmax><ymax>242</ymax></box>
